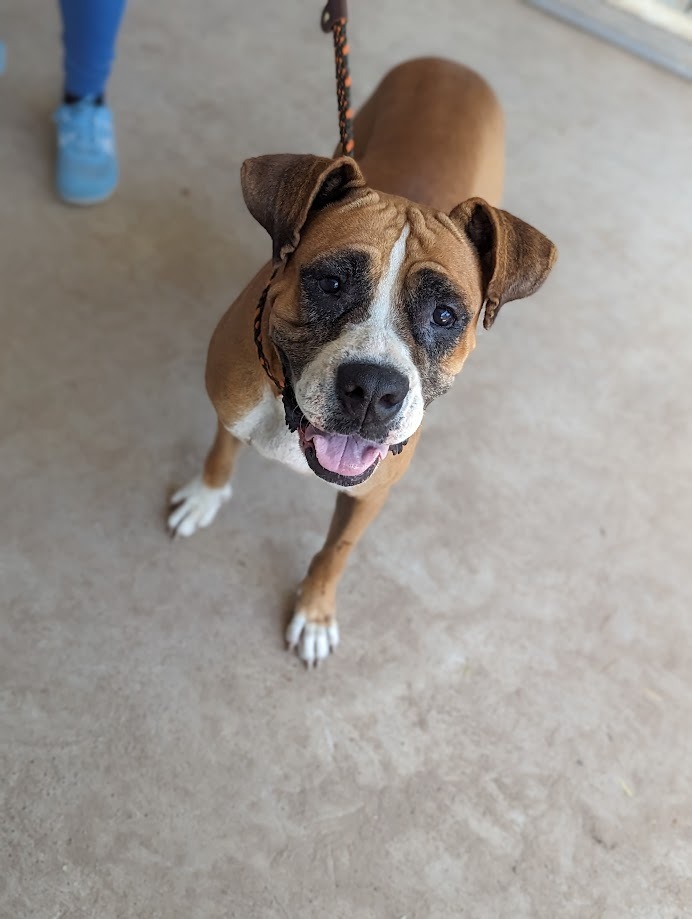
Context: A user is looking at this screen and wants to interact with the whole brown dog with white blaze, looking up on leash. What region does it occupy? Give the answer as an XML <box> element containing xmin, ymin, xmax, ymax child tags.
<box><xmin>169</xmin><ymin>59</ymin><xmax>556</xmax><ymax>666</ymax></box>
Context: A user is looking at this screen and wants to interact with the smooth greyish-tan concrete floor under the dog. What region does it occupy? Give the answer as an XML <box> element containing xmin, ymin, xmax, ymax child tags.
<box><xmin>0</xmin><ymin>0</ymin><xmax>692</xmax><ymax>919</ymax></box>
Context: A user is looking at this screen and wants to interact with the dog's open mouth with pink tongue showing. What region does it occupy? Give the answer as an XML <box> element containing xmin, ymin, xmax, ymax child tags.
<box><xmin>299</xmin><ymin>423</ymin><xmax>389</xmax><ymax>485</ymax></box>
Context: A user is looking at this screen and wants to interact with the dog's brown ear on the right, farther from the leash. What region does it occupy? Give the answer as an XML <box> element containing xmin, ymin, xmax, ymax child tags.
<box><xmin>449</xmin><ymin>198</ymin><xmax>557</xmax><ymax>329</ymax></box>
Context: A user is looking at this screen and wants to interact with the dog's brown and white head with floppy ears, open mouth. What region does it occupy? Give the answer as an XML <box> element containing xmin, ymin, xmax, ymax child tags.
<box><xmin>241</xmin><ymin>154</ymin><xmax>556</xmax><ymax>485</ymax></box>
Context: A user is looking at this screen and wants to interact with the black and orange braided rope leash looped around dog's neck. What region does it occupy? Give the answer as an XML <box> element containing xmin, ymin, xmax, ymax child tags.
<box><xmin>254</xmin><ymin>0</ymin><xmax>354</xmax><ymax>395</ymax></box>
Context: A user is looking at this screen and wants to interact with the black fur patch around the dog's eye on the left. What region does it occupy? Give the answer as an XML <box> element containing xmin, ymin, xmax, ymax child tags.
<box><xmin>300</xmin><ymin>249</ymin><xmax>375</xmax><ymax>329</ymax></box>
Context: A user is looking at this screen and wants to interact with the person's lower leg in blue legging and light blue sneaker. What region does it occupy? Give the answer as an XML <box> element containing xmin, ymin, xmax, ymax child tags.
<box><xmin>55</xmin><ymin>0</ymin><xmax>126</xmax><ymax>204</ymax></box>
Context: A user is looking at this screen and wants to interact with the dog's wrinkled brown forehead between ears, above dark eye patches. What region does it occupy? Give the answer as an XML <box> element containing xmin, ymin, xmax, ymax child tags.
<box><xmin>295</xmin><ymin>194</ymin><xmax>480</xmax><ymax>298</ymax></box>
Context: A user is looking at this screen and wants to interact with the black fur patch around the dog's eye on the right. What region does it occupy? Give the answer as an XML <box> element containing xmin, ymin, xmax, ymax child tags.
<box><xmin>406</xmin><ymin>268</ymin><xmax>471</xmax><ymax>361</ymax></box>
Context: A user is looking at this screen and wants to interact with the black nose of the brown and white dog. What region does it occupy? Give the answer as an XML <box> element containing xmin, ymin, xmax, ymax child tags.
<box><xmin>336</xmin><ymin>361</ymin><xmax>408</xmax><ymax>426</ymax></box>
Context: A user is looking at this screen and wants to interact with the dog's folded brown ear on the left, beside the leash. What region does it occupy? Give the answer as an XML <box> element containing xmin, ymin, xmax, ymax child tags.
<box><xmin>240</xmin><ymin>153</ymin><xmax>365</xmax><ymax>262</ymax></box>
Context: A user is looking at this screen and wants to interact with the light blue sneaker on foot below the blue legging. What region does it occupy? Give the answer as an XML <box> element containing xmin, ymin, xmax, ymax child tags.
<box><xmin>53</xmin><ymin>96</ymin><xmax>118</xmax><ymax>204</ymax></box>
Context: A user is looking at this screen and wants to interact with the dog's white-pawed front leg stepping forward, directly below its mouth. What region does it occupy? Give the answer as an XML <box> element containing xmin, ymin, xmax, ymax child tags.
<box><xmin>286</xmin><ymin>487</ymin><xmax>389</xmax><ymax>667</ymax></box>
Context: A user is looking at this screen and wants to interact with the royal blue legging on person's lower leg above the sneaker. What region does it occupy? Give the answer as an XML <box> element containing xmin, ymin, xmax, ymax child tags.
<box><xmin>60</xmin><ymin>0</ymin><xmax>127</xmax><ymax>96</ymax></box>
